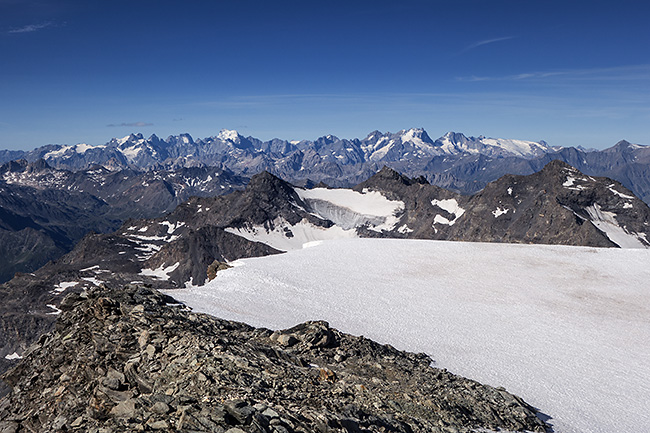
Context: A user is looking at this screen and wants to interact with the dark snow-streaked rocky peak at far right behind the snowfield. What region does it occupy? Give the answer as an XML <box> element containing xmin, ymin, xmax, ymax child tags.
<box><xmin>449</xmin><ymin>161</ymin><xmax>650</xmax><ymax>247</ymax></box>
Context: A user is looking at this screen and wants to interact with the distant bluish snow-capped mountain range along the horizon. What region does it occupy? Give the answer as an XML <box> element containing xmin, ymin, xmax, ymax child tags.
<box><xmin>5</xmin><ymin>128</ymin><xmax>650</xmax><ymax>202</ymax></box>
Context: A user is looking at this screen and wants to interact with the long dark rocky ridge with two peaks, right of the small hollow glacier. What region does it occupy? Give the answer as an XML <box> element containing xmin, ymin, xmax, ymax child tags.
<box><xmin>354</xmin><ymin>160</ymin><xmax>650</xmax><ymax>248</ymax></box>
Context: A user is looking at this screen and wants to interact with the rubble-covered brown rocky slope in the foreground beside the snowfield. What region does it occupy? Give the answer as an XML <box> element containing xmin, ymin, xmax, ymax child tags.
<box><xmin>0</xmin><ymin>285</ymin><xmax>546</xmax><ymax>433</ymax></box>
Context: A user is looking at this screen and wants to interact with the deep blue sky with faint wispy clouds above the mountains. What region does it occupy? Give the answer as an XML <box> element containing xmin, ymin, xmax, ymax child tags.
<box><xmin>0</xmin><ymin>0</ymin><xmax>650</xmax><ymax>149</ymax></box>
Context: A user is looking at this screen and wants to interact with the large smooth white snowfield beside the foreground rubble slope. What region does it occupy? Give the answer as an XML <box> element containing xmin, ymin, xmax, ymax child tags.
<box><xmin>168</xmin><ymin>239</ymin><xmax>650</xmax><ymax>433</ymax></box>
